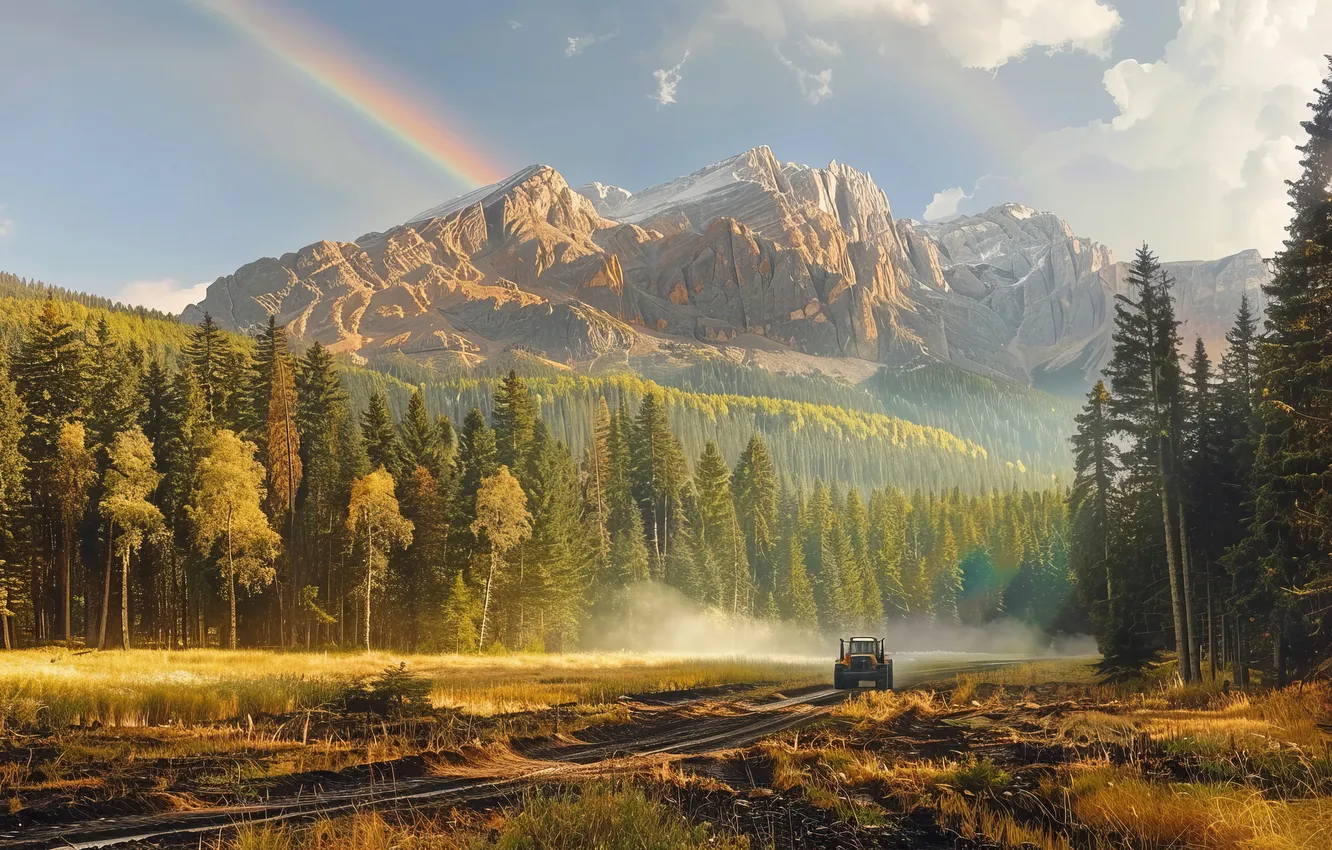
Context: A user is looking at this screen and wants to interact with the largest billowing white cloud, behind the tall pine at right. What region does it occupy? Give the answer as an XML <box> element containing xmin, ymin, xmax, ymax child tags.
<box><xmin>940</xmin><ymin>0</ymin><xmax>1332</xmax><ymax>260</ymax></box>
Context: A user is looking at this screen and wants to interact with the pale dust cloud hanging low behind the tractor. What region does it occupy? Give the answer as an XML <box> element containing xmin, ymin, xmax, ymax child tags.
<box><xmin>583</xmin><ymin>582</ymin><xmax>1096</xmax><ymax>659</ymax></box>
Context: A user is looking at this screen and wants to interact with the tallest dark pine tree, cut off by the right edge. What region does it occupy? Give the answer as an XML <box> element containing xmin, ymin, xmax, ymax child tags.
<box><xmin>1228</xmin><ymin>59</ymin><xmax>1332</xmax><ymax>686</ymax></box>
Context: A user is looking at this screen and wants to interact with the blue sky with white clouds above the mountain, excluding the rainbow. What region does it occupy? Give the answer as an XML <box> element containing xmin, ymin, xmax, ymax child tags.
<box><xmin>0</xmin><ymin>0</ymin><xmax>1332</xmax><ymax>309</ymax></box>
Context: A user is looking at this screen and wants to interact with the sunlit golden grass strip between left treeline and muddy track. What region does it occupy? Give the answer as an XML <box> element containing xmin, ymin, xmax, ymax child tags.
<box><xmin>0</xmin><ymin>649</ymin><xmax>827</xmax><ymax>729</ymax></box>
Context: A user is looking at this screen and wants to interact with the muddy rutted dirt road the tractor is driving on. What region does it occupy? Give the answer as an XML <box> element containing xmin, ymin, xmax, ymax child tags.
<box><xmin>0</xmin><ymin>658</ymin><xmax>1018</xmax><ymax>850</ymax></box>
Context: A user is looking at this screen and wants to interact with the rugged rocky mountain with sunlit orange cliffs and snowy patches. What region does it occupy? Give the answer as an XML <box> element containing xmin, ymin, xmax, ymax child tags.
<box><xmin>184</xmin><ymin>147</ymin><xmax>1265</xmax><ymax>394</ymax></box>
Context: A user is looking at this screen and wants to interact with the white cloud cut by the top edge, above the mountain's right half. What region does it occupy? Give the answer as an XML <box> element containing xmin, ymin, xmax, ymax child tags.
<box><xmin>721</xmin><ymin>0</ymin><xmax>1118</xmax><ymax>69</ymax></box>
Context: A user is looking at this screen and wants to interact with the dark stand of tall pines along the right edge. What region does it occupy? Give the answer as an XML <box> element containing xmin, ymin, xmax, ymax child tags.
<box><xmin>1072</xmin><ymin>61</ymin><xmax>1332</xmax><ymax>685</ymax></box>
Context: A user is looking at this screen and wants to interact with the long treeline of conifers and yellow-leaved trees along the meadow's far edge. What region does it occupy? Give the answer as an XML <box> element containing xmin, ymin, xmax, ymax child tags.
<box><xmin>0</xmin><ymin>306</ymin><xmax>1070</xmax><ymax>651</ymax></box>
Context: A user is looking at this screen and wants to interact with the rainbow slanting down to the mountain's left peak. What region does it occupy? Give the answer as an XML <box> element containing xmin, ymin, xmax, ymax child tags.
<box><xmin>194</xmin><ymin>0</ymin><xmax>506</xmax><ymax>189</ymax></box>
